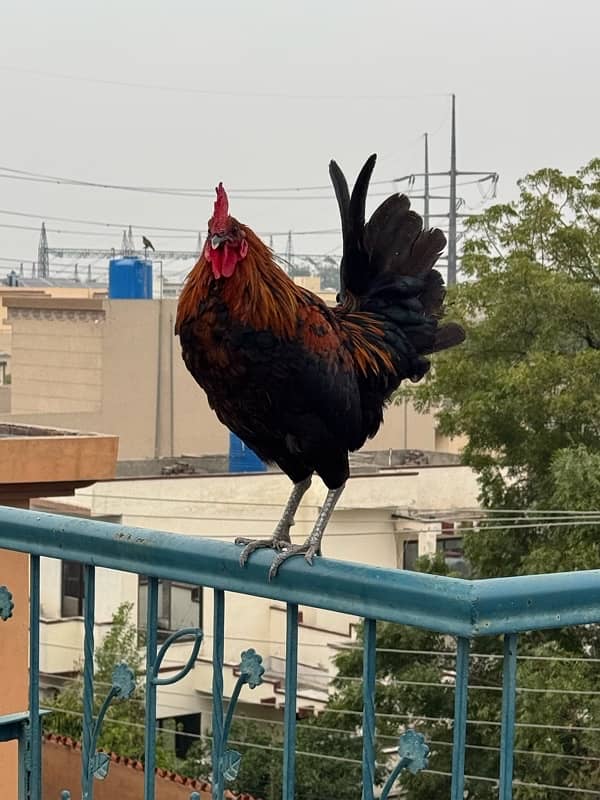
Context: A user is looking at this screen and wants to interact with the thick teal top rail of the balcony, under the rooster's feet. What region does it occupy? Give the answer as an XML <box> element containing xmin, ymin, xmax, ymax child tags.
<box><xmin>0</xmin><ymin>507</ymin><xmax>600</xmax><ymax>637</ymax></box>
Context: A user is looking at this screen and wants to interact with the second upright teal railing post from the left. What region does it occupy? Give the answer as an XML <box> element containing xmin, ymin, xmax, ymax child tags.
<box><xmin>81</xmin><ymin>564</ymin><xmax>96</xmax><ymax>800</ymax></box>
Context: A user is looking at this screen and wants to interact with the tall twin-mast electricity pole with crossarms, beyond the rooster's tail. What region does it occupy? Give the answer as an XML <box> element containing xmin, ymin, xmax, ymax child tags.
<box><xmin>393</xmin><ymin>94</ymin><xmax>498</xmax><ymax>286</ymax></box>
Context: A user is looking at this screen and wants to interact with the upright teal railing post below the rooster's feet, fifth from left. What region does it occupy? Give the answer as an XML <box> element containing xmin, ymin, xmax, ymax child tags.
<box><xmin>283</xmin><ymin>603</ymin><xmax>298</xmax><ymax>800</ymax></box>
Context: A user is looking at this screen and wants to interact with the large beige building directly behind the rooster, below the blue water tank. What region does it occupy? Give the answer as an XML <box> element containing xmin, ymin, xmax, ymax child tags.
<box><xmin>0</xmin><ymin>294</ymin><xmax>464</xmax><ymax>460</ymax></box>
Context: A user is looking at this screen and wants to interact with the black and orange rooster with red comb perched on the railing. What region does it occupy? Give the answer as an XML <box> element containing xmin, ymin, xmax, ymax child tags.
<box><xmin>175</xmin><ymin>155</ymin><xmax>464</xmax><ymax>579</ymax></box>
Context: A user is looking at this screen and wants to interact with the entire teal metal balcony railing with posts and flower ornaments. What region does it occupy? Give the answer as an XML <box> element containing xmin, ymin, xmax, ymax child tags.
<box><xmin>0</xmin><ymin>508</ymin><xmax>600</xmax><ymax>800</ymax></box>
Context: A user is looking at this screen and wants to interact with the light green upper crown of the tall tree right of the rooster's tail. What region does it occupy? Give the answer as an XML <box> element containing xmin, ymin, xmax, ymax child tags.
<box><xmin>411</xmin><ymin>159</ymin><xmax>600</xmax><ymax>507</ymax></box>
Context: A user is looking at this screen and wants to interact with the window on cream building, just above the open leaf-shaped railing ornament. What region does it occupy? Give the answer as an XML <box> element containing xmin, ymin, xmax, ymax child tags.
<box><xmin>138</xmin><ymin>575</ymin><xmax>202</xmax><ymax>642</ymax></box>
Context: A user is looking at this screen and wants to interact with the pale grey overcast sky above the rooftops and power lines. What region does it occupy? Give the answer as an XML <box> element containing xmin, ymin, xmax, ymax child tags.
<box><xmin>0</xmin><ymin>0</ymin><xmax>600</xmax><ymax>268</ymax></box>
